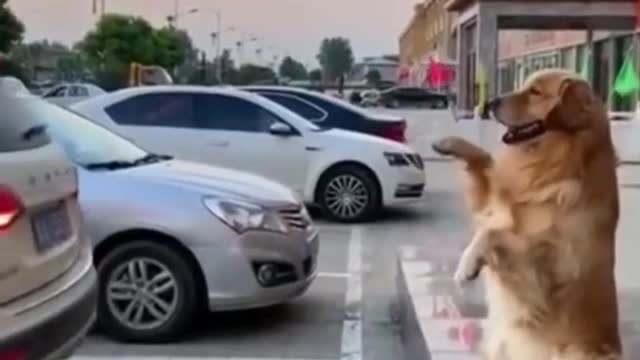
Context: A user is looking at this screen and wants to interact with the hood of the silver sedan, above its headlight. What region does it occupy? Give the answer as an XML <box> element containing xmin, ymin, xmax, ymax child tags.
<box><xmin>123</xmin><ymin>160</ymin><xmax>300</xmax><ymax>205</ymax></box>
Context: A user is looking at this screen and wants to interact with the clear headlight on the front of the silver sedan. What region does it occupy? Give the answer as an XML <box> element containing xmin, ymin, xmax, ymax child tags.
<box><xmin>204</xmin><ymin>197</ymin><xmax>288</xmax><ymax>234</ymax></box>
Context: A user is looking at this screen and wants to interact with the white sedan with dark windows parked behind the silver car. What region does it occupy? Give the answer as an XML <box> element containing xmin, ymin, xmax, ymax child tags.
<box><xmin>72</xmin><ymin>86</ymin><xmax>425</xmax><ymax>222</ymax></box>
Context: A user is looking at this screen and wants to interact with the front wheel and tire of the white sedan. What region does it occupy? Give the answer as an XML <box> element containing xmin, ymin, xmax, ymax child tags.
<box><xmin>316</xmin><ymin>165</ymin><xmax>382</xmax><ymax>223</ymax></box>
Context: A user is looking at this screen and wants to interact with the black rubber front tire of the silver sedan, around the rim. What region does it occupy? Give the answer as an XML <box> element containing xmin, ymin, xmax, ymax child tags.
<box><xmin>97</xmin><ymin>240</ymin><xmax>200</xmax><ymax>343</ymax></box>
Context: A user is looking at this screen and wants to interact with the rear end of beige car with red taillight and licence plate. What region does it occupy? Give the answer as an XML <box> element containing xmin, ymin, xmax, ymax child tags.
<box><xmin>0</xmin><ymin>86</ymin><xmax>97</xmax><ymax>359</ymax></box>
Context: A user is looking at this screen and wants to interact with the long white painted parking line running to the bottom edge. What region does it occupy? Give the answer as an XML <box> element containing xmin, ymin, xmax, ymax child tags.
<box><xmin>340</xmin><ymin>226</ymin><xmax>362</xmax><ymax>360</ymax></box>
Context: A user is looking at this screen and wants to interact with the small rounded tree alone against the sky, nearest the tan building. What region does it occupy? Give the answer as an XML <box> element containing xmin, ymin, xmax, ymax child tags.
<box><xmin>317</xmin><ymin>37</ymin><xmax>354</xmax><ymax>81</ymax></box>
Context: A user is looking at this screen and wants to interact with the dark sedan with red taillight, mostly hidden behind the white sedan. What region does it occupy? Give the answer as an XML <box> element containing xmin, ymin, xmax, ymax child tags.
<box><xmin>241</xmin><ymin>86</ymin><xmax>407</xmax><ymax>142</ymax></box>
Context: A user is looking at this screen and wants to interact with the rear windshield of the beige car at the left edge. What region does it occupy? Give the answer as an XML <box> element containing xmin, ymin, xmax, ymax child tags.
<box><xmin>0</xmin><ymin>93</ymin><xmax>51</xmax><ymax>153</ymax></box>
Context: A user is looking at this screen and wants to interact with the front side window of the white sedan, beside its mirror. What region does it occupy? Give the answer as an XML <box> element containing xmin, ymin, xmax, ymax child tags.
<box><xmin>196</xmin><ymin>94</ymin><xmax>280</xmax><ymax>132</ymax></box>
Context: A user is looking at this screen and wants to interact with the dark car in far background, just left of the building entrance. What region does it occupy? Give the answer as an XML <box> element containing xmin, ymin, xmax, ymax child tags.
<box><xmin>380</xmin><ymin>87</ymin><xmax>449</xmax><ymax>109</ymax></box>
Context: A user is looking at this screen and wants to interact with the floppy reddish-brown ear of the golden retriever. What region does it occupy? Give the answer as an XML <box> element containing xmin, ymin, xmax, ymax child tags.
<box><xmin>547</xmin><ymin>78</ymin><xmax>596</xmax><ymax>131</ymax></box>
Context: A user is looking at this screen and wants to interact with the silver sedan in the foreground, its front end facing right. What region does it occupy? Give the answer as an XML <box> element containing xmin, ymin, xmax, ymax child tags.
<box><xmin>33</xmin><ymin>98</ymin><xmax>318</xmax><ymax>342</ymax></box>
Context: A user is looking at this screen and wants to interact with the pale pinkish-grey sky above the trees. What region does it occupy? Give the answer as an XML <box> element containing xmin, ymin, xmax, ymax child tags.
<box><xmin>9</xmin><ymin>0</ymin><xmax>418</xmax><ymax>66</ymax></box>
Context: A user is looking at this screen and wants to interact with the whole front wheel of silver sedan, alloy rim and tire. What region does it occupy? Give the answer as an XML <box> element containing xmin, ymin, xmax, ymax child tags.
<box><xmin>97</xmin><ymin>239</ymin><xmax>198</xmax><ymax>343</ymax></box>
